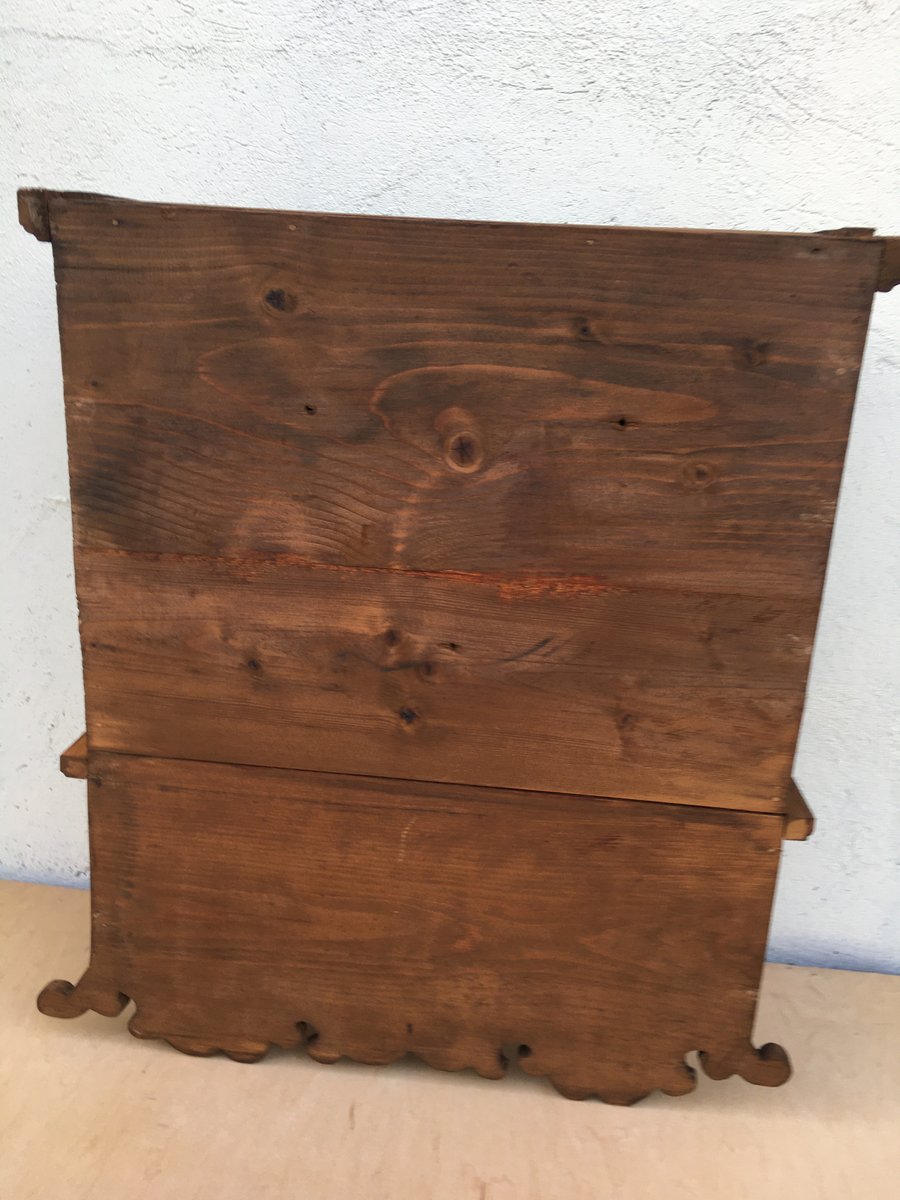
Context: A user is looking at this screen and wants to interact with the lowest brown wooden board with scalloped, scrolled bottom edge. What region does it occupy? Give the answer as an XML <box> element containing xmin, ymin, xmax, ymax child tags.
<box><xmin>41</xmin><ymin>754</ymin><xmax>788</xmax><ymax>1103</ymax></box>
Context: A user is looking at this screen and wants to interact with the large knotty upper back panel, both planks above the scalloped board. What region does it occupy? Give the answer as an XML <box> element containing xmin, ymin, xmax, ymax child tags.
<box><xmin>37</xmin><ymin>193</ymin><xmax>887</xmax><ymax>811</ymax></box>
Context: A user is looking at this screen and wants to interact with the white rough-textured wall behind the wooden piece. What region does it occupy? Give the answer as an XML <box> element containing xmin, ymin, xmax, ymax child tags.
<box><xmin>0</xmin><ymin>0</ymin><xmax>900</xmax><ymax>971</ymax></box>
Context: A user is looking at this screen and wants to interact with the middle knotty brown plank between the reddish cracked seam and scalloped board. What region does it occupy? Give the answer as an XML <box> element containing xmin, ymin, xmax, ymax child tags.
<box><xmin>79</xmin><ymin>550</ymin><xmax>815</xmax><ymax>811</ymax></box>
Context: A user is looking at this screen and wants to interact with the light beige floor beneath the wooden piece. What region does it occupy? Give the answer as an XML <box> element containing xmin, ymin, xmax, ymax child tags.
<box><xmin>0</xmin><ymin>883</ymin><xmax>900</xmax><ymax>1200</ymax></box>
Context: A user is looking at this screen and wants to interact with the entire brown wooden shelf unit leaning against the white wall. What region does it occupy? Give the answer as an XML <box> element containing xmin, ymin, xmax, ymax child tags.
<box><xmin>20</xmin><ymin>192</ymin><xmax>900</xmax><ymax>1103</ymax></box>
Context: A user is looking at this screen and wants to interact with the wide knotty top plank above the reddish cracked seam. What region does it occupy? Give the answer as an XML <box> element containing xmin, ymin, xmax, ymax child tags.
<box><xmin>49</xmin><ymin>194</ymin><xmax>883</xmax><ymax>596</ymax></box>
